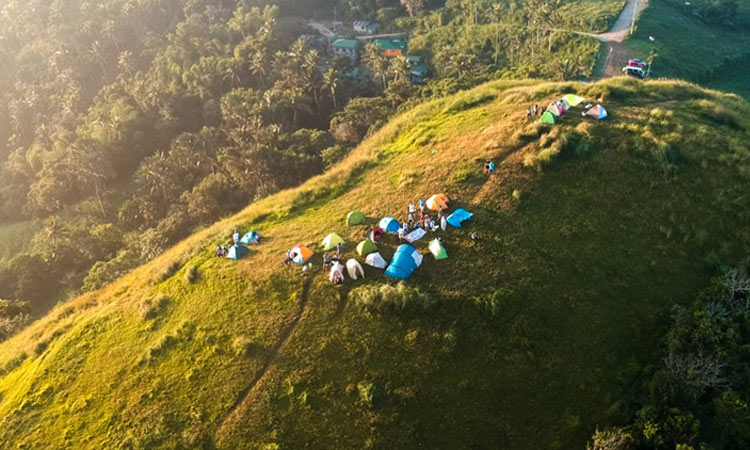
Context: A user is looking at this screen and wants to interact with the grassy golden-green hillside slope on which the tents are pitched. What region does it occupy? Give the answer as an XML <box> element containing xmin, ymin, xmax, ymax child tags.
<box><xmin>0</xmin><ymin>75</ymin><xmax>750</xmax><ymax>449</ymax></box>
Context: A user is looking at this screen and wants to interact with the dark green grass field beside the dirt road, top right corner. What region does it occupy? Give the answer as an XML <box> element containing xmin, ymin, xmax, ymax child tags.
<box><xmin>625</xmin><ymin>0</ymin><xmax>750</xmax><ymax>98</ymax></box>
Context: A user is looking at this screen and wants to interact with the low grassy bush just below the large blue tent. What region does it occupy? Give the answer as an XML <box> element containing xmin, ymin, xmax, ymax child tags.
<box><xmin>349</xmin><ymin>282</ymin><xmax>435</xmax><ymax>314</ymax></box>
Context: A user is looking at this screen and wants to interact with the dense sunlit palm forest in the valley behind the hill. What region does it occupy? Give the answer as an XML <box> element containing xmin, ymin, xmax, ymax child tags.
<box><xmin>0</xmin><ymin>0</ymin><xmax>622</xmax><ymax>334</ymax></box>
